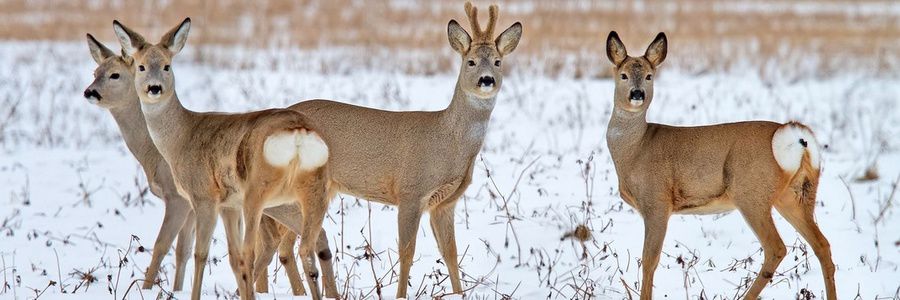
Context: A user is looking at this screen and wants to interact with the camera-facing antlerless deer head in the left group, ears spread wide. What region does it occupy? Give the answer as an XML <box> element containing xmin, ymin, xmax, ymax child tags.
<box><xmin>113</xmin><ymin>18</ymin><xmax>191</xmax><ymax>104</ymax></box>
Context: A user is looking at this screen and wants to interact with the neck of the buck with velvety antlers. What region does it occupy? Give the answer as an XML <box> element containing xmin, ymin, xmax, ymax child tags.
<box><xmin>441</xmin><ymin>81</ymin><xmax>496</xmax><ymax>152</ymax></box>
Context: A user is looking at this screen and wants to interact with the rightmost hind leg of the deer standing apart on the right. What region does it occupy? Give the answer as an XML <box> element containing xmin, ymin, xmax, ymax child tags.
<box><xmin>775</xmin><ymin>193</ymin><xmax>837</xmax><ymax>300</ymax></box>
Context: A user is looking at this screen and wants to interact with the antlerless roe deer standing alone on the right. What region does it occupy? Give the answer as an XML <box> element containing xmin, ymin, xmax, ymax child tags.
<box><xmin>606</xmin><ymin>31</ymin><xmax>836</xmax><ymax>300</ymax></box>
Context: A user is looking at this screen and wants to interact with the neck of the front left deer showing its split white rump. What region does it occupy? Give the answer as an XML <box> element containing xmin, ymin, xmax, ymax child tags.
<box><xmin>141</xmin><ymin>93</ymin><xmax>192</xmax><ymax>160</ymax></box>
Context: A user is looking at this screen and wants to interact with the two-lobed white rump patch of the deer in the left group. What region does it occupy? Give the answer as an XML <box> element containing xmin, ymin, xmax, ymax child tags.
<box><xmin>263</xmin><ymin>129</ymin><xmax>328</xmax><ymax>171</ymax></box>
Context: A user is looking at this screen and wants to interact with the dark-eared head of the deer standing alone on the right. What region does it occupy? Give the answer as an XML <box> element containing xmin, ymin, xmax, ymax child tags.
<box><xmin>606</xmin><ymin>31</ymin><xmax>668</xmax><ymax>112</ymax></box>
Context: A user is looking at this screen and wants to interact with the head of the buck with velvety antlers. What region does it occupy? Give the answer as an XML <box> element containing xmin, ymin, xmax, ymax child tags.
<box><xmin>447</xmin><ymin>2</ymin><xmax>522</xmax><ymax>99</ymax></box>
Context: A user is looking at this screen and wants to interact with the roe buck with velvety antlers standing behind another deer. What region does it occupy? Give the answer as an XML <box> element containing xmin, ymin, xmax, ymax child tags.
<box><xmin>290</xmin><ymin>2</ymin><xmax>522</xmax><ymax>298</ymax></box>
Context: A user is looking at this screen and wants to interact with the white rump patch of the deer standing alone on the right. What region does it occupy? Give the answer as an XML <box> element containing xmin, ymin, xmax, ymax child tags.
<box><xmin>772</xmin><ymin>123</ymin><xmax>819</xmax><ymax>173</ymax></box>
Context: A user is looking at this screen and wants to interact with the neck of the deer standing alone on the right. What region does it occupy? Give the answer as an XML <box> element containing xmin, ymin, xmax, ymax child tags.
<box><xmin>606</xmin><ymin>105</ymin><xmax>647</xmax><ymax>168</ymax></box>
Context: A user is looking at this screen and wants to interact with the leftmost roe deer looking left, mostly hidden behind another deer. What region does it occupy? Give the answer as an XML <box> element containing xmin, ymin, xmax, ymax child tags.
<box><xmin>84</xmin><ymin>34</ymin><xmax>320</xmax><ymax>295</ymax></box>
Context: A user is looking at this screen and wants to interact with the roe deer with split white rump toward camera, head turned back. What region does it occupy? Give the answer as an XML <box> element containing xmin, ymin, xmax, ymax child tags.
<box><xmin>113</xmin><ymin>18</ymin><xmax>336</xmax><ymax>300</ymax></box>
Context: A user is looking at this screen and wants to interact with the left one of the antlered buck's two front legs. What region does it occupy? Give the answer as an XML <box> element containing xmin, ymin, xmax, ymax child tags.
<box><xmin>397</xmin><ymin>199</ymin><xmax>422</xmax><ymax>298</ymax></box>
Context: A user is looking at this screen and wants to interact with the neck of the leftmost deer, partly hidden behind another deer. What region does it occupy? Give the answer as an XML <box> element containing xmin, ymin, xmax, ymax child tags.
<box><xmin>109</xmin><ymin>93</ymin><xmax>161</xmax><ymax>175</ymax></box>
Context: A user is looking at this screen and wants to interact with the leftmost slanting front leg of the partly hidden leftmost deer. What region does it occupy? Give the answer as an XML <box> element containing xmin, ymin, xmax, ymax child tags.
<box><xmin>142</xmin><ymin>197</ymin><xmax>191</xmax><ymax>289</ymax></box>
